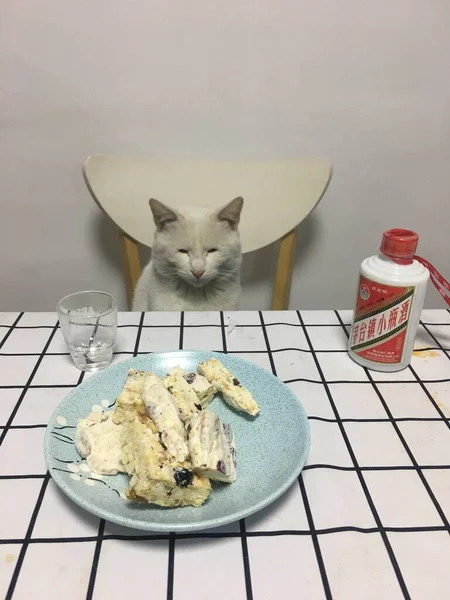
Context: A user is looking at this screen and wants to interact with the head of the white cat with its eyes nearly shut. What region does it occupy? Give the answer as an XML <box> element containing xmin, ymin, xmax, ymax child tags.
<box><xmin>150</xmin><ymin>198</ymin><xmax>244</xmax><ymax>287</ymax></box>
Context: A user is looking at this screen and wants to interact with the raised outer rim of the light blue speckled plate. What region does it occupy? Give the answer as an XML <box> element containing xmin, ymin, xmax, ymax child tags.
<box><xmin>44</xmin><ymin>350</ymin><xmax>311</xmax><ymax>533</ymax></box>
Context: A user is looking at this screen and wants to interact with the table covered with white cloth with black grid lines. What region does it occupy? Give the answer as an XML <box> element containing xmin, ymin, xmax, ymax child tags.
<box><xmin>0</xmin><ymin>309</ymin><xmax>450</xmax><ymax>600</ymax></box>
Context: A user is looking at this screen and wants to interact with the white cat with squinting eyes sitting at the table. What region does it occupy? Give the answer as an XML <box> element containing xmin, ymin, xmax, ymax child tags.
<box><xmin>133</xmin><ymin>198</ymin><xmax>244</xmax><ymax>311</ymax></box>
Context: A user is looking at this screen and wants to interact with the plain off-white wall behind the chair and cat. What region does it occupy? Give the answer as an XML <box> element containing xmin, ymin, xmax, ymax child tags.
<box><xmin>0</xmin><ymin>0</ymin><xmax>450</xmax><ymax>310</ymax></box>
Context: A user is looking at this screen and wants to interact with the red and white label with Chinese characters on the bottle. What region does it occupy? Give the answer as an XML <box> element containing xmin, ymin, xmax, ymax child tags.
<box><xmin>350</xmin><ymin>275</ymin><xmax>415</xmax><ymax>364</ymax></box>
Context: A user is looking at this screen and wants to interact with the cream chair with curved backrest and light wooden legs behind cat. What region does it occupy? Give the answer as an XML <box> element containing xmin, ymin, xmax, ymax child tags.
<box><xmin>83</xmin><ymin>155</ymin><xmax>332</xmax><ymax>310</ymax></box>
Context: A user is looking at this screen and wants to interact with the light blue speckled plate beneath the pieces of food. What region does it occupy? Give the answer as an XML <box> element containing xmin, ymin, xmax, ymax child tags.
<box><xmin>45</xmin><ymin>351</ymin><xmax>310</xmax><ymax>531</ymax></box>
